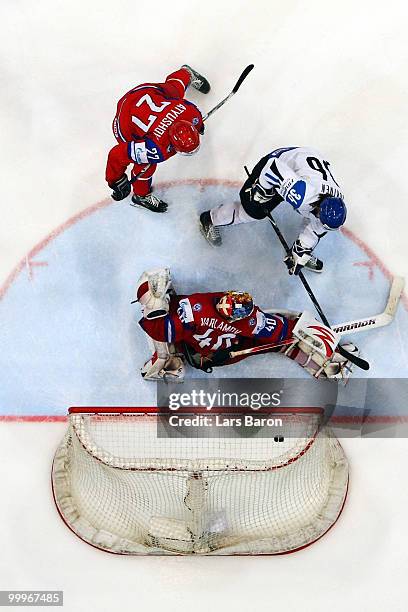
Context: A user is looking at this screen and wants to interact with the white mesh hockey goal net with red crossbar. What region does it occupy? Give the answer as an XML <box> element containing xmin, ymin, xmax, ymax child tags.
<box><xmin>52</xmin><ymin>408</ymin><xmax>348</xmax><ymax>554</ymax></box>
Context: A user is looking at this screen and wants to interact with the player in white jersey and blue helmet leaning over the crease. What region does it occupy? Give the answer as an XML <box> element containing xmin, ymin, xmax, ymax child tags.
<box><xmin>200</xmin><ymin>147</ymin><xmax>347</xmax><ymax>274</ymax></box>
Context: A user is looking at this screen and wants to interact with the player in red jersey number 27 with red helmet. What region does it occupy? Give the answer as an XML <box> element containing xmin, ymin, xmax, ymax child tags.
<box><xmin>106</xmin><ymin>65</ymin><xmax>210</xmax><ymax>212</ymax></box>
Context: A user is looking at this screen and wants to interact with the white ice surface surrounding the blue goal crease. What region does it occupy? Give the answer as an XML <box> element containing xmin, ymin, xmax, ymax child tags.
<box><xmin>0</xmin><ymin>0</ymin><xmax>408</xmax><ymax>612</ymax></box>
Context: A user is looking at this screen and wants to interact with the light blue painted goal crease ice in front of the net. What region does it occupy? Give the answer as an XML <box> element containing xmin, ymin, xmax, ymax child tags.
<box><xmin>0</xmin><ymin>183</ymin><xmax>408</xmax><ymax>414</ymax></box>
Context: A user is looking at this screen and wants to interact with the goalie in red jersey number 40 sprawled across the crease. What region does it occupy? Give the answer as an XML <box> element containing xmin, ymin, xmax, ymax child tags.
<box><xmin>135</xmin><ymin>268</ymin><xmax>358</xmax><ymax>382</ymax></box>
